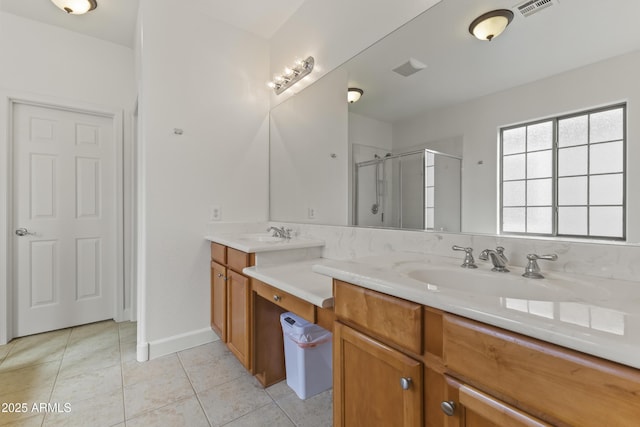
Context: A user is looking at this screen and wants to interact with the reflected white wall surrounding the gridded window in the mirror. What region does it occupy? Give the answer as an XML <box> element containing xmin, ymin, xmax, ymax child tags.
<box><xmin>394</xmin><ymin>52</ymin><xmax>640</xmax><ymax>242</ymax></box>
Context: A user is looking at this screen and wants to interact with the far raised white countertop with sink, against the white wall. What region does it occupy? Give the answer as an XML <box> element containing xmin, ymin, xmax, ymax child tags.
<box><xmin>205</xmin><ymin>232</ymin><xmax>324</xmax><ymax>253</ymax></box>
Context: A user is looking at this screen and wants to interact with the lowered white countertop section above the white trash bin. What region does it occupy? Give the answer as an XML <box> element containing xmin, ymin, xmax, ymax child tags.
<box><xmin>242</xmin><ymin>258</ymin><xmax>333</xmax><ymax>308</ymax></box>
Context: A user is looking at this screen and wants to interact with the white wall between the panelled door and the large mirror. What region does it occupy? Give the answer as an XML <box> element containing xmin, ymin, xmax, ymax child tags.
<box><xmin>138</xmin><ymin>0</ymin><xmax>269</xmax><ymax>358</ymax></box>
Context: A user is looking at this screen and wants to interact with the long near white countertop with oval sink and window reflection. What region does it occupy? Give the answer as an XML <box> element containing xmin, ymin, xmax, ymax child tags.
<box><xmin>312</xmin><ymin>253</ymin><xmax>640</xmax><ymax>368</ymax></box>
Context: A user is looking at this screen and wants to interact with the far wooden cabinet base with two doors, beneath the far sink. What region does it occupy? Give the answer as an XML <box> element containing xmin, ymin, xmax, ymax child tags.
<box><xmin>211</xmin><ymin>242</ymin><xmax>255</xmax><ymax>371</ymax></box>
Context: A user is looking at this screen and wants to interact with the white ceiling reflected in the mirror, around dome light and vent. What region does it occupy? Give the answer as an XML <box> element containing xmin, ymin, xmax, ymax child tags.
<box><xmin>343</xmin><ymin>0</ymin><xmax>640</xmax><ymax>123</ymax></box>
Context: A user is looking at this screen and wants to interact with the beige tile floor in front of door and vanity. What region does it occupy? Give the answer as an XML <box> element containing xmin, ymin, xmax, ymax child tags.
<box><xmin>0</xmin><ymin>321</ymin><xmax>332</xmax><ymax>427</ymax></box>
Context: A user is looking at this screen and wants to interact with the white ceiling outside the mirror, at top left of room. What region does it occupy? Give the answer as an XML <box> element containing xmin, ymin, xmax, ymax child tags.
<box><xmin>0</xmin><ymin>0</ymin><xmax>305</xmax><ymax>48</ymax></box>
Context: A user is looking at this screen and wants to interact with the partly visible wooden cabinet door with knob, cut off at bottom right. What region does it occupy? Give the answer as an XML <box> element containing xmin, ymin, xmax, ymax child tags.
<box><xmin>443</xmin><ymin>378</ymin><xmax>551</xmax><ymax>427</ymax></box>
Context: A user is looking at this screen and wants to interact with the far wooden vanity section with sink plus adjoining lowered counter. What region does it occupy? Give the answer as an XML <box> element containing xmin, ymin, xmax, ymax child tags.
<box><xmin>209</xmin><ymin>233</ymin><xmax>333</xmax><ymax>387</ymax></box>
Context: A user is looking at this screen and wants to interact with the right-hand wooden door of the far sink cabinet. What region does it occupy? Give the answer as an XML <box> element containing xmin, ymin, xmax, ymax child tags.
<box><xmin>227</xmin><ymin>269</ymin><xmax>251</xmax><ymax>370</ymax></box>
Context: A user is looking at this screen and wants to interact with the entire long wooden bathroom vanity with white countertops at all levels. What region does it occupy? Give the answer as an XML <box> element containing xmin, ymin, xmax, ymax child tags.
<box><xmin>206</xmin><ymin>232</ymin><xmax>640</xmax><ymax>427</ymax></box>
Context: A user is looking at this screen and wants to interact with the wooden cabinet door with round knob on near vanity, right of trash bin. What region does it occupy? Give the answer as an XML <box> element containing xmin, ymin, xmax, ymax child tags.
<box><xmin>333</xmin><ymin>322</ymin><xmax>423</xmax><ymax>427</ymax></box>
